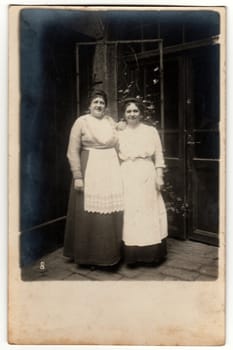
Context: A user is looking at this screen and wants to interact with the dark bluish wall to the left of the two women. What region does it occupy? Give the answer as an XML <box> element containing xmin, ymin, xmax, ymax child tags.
<box><xmin>20</xmin><ymin>9</ymin><xmax>103</xmax><ymax>265</ymax></box>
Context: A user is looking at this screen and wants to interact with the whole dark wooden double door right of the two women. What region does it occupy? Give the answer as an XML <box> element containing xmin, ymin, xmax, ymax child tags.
<box><xmin>164</xmin><ymin>45</ymin><xmax>220</xmax><ymax>245</ymax></box>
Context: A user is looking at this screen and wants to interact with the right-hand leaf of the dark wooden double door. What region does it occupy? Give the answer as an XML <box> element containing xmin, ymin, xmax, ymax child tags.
<box><xmin>186</xmin><ymin>45</ymin><xmax>219</xmax><ymax>245</ymax></box>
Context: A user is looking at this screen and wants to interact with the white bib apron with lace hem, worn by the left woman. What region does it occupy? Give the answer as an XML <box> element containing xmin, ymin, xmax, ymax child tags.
<box><xmin>84</xmin><ymin>118</ymin><xmax>123</xmax><ymax>214</ymax></box>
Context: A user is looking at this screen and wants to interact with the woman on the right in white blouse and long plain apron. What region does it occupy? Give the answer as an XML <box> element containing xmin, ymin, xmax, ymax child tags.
<box><xmin>119</xmin><ymin>99</ymin><xmax>167</xmax><ymax>265</ymax></box>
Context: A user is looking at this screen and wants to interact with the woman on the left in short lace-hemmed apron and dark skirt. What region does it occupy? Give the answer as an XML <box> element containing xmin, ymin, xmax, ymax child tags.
<box><xmin>64</xmin><ymin>91</ymin><xmax>123</xmax><ymax>266</ymax></box>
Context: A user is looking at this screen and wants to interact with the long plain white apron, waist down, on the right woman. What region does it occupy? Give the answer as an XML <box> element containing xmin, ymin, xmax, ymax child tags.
<box><xmin>121</xmin><ymin>158</ymin><xmax>167</xmax><ymax>246</ymax></box>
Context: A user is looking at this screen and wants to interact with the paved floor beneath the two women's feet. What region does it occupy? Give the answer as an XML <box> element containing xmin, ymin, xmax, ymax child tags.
<box><xmin>22</xmin><ymin>238</ymin><xmax>218</xmax><ymax>281</ymax></box>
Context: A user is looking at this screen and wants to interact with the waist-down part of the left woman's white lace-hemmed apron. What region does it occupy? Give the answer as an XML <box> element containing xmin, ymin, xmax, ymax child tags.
<box><xmin>84</xmin><ymin>148</ymin><xmax>123</xmax><ymax>214</ymax></box>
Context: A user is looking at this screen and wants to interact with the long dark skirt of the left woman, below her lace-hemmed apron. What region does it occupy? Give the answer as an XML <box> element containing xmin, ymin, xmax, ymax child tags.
<box><xmin>63</xmin><ymin>151</ymin><xmax>122</xmax><ymax>266</ymax></box>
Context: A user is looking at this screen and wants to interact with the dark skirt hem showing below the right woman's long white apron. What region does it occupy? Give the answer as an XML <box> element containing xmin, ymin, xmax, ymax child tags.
<box><xmin>124</xmin><ymin>238</ymin><xmax>167</xmax><ymax>264</ymax></box>
